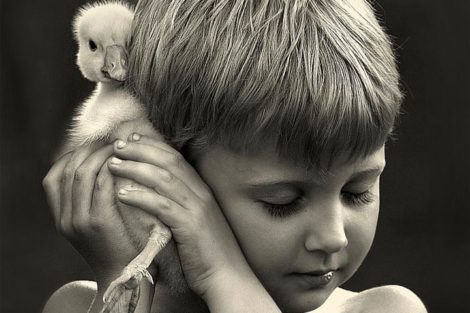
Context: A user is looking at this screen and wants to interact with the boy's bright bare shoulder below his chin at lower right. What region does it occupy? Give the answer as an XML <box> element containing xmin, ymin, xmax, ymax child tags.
<box><xmin>345</xmin><ymin>285</ymin><xmax>427</xmax><ymax>313</ymax></box>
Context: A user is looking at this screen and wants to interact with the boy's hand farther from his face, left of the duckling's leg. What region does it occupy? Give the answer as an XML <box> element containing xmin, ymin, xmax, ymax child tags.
<box><xmin>43</xmin><ymin>145</ymin><xmax>143</xmax><ymax>290</ymax></box>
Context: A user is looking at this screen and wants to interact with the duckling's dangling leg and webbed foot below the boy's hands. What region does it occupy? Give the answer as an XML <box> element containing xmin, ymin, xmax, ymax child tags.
<box><xmin>101</xmin><ymin>223</ymin><xmax>171</xmax><ymax>313</ymax></box>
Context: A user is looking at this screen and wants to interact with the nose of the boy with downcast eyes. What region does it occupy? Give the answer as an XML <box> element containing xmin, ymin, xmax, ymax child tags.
<box><xmin>305</xmin><ymin>203</ymin><xmax>348</xmax><ymax>254</ymax></box>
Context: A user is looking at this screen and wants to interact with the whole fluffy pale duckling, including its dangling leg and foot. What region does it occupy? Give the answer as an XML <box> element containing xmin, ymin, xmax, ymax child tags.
<box><xmin>61</xmin><ymin>1</ymin><xmax>171</xmax><ymax>313</ymax></box>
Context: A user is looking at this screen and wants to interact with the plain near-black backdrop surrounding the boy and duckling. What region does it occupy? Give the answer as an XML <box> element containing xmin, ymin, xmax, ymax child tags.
<box><xmin>0</xmin><ymin>0</ymin><xmax>470</xmax><ymax>312</ymax></box>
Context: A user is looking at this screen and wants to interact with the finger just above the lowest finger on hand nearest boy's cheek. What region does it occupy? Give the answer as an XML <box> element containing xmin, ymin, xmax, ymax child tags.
<box><xmin>108</xmin><ymin>157</ymin><xmax>200</xmax><ymax>208</ymax></box>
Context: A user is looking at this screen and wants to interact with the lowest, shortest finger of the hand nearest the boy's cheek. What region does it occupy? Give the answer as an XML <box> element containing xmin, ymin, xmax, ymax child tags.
<box><xmin>118</xmin><ymin>187</ymin><xmax>186</xmax><ymax>228</ymax></box>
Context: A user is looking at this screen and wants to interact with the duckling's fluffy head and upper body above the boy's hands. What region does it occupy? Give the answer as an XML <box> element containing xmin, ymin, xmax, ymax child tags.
<box><xmin>65</xmin><ymin>2</ymin><xmax>146</xmax><ymax>152</ymax></box>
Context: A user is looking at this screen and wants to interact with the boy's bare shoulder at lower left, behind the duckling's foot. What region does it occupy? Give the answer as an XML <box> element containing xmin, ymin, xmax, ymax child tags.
<box><xmin>42</xmin><ymin>280</ymin><xmax>96</xmax><ymax>313</ymax></box>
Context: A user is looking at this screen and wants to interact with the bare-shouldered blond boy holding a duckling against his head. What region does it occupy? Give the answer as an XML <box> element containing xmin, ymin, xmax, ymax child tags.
<box><xmin>44</xmin><ymin>0</ymin><xmax>425</xmax><ymax>312</ymax></box>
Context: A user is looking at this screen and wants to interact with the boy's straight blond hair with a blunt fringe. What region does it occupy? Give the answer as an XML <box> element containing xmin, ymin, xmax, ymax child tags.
<box><xmin>129</xmin><ymin>0</ymin><xmax>402</xmax><ymax>165</ymax></box>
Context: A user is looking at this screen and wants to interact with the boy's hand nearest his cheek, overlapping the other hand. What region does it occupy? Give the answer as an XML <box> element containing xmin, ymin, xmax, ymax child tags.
<box><xmin>108</xmin><ymin>134</ymin><xmax>251</xmax><ymax>298</ymax></box>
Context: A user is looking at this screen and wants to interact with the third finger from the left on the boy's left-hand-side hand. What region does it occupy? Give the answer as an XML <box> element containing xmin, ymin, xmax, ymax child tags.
<box><xmin>72</xmin><ymin>145</ymin><xmax>113</xmax><ymax>231</ymax></box>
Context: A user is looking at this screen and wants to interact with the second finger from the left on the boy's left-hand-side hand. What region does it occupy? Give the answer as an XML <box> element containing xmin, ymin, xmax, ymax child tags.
<box><xmin>60</xmin><ymin>145</ymin><xmax>99</xmax><ymax>236</ymax></box>
